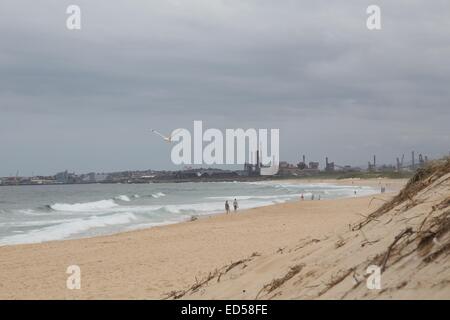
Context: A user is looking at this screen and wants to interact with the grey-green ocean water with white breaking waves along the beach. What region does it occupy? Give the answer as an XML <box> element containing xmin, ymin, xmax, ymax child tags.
<box><xmin>0</xmin><ymin>181</ymin><xmax>378</xmax><ymax>245</ymax></box>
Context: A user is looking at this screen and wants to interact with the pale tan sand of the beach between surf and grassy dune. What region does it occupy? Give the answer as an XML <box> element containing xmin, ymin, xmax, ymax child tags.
<box><xmin>0</xmin><ymin>179</ymin><xmax>449</xmax><ymax>299</ymax></box>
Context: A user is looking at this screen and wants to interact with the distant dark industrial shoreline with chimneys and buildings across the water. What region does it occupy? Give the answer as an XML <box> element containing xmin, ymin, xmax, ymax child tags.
<box><xmin>0</xmin><ymin>151</ymin><xmax>438</xmax><ymax>186</ymax></box>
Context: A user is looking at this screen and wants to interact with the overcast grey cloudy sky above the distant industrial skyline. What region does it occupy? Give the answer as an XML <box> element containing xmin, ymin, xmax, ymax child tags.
<box><xmin>0</xmin><ymin>0</ymin><xmax>450</xmax><ymax>176</ymax></box>
